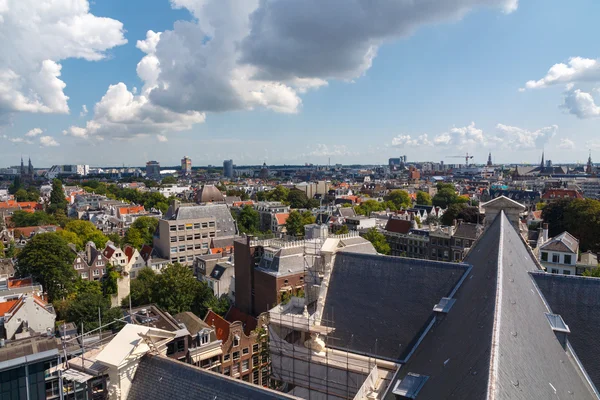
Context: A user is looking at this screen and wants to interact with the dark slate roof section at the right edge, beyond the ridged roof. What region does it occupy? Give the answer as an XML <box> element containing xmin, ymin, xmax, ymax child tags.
<box><xmin>531</xmin><ymin>272</ymin><xmax>600</xmax><ymax>387</ymax></box>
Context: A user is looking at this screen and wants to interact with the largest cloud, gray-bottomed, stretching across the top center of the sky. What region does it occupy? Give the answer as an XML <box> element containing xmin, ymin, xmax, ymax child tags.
<box><xmin>74</xmin><ymin>0</ymin><xmax>518</xmax><ymax>136</ymax></box>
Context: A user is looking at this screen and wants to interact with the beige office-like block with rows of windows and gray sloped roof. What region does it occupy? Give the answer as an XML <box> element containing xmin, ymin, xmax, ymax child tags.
<box><xmin>154</xmin><ymin>200</ymin><xmax>236</xmax><ymax>265</ymax></box>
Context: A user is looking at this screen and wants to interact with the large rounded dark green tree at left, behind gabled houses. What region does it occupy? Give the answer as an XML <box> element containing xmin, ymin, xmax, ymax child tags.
<box><xmin>17</xmin><ymin>233</ymin><xmax>76</xmax><ymax>300</ymax></box>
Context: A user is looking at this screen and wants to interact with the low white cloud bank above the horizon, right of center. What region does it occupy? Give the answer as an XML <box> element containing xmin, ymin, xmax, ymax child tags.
<box><xmin>392</xmin><ymin>122</ymin><xmax>558</xmax><ymax>150</ymax></box>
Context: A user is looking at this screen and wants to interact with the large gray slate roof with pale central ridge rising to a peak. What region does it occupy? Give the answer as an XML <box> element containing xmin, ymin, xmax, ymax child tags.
<box><xmin>386</xmin><ymin>213</ymin><xmax>596</xmax><ymax>400</ymax></box>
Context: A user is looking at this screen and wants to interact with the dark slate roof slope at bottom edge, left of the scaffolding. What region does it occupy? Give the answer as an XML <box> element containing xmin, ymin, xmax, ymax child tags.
<box><xmin>127</xmin><ymin>355</ymin><xmax>296</xmax><ymax>400</ymax></box>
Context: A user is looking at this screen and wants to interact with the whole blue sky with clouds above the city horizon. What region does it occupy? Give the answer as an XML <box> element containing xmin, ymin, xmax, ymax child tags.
<box><xmin>0</xmin><ymin>0</ymin><xmax>600</xmax><ymax>167</ymax></box>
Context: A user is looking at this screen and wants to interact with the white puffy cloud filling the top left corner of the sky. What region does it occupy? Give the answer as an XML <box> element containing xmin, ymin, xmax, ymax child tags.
<box><xmin>0</xmin><ymin>0</ymin><xmax>127</xmax><ymax>113</ymax></box>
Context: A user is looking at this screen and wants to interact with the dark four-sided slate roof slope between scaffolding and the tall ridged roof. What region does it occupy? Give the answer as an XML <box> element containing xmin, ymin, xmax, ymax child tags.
<box><xmin>321</xmin><ymin>250</ymin><xmax>468</xmax><ymax>360</ymax></box>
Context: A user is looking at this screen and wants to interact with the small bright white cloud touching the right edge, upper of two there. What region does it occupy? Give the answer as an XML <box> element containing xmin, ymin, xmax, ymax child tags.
<box><xmin>525</xmin><ymin>57</ymin><xmax>600</xmax><ymax>89</ymax></box>
